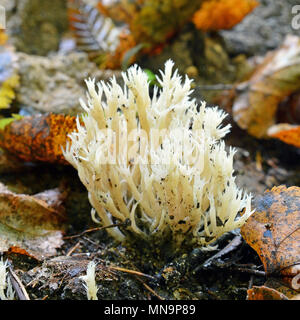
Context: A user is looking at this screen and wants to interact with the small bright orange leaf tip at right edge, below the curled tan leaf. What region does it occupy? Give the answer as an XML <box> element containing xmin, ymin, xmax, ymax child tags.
<box><xmin>267</xmin><ymin>123</ymin><xmax>300</xmax><ymax>148</ymax></box>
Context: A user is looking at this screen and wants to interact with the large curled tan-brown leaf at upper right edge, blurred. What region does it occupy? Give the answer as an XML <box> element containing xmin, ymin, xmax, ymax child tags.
<box><xmin>232</xmin><ymin>35</ymin><xmax>300</xmax><ymax>138</ymax></box>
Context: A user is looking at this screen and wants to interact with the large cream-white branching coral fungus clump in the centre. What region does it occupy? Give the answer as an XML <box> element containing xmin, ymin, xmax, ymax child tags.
<box><xmin>64</xmin><ymin>60</ymin><xmax>252</xmax><ymax>245</ymax></box>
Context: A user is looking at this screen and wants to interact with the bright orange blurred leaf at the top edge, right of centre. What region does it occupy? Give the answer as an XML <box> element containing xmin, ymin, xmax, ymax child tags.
<box><xmin>192</xmin><ymin>0</ymin><xmax>259</xmax><ymax>31</ymax></box>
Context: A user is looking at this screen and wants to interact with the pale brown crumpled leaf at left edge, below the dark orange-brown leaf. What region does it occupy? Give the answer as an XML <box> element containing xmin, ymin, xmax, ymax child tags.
<box><xmin>0</xmin><ymin>184</ymin><xmax>66</xmax><ymax>259</ymax></box>
